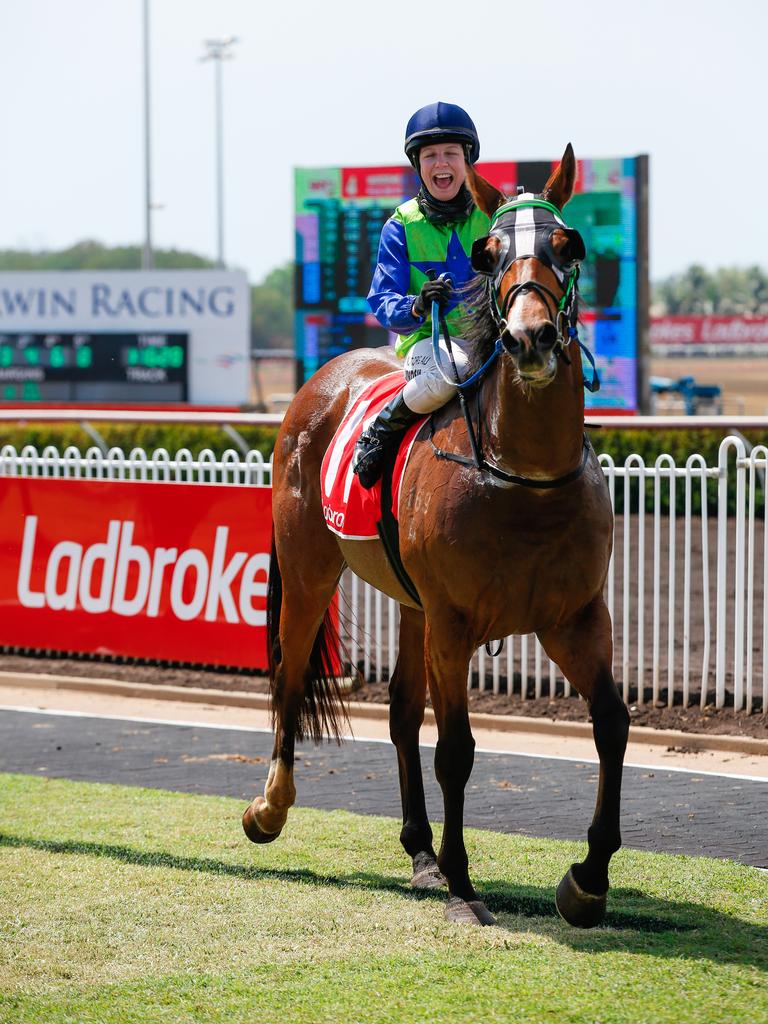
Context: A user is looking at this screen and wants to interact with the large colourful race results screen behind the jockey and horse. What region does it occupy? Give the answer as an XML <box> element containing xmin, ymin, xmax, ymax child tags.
<box><xmin>295</xmin><ymin>157</ymin><xmax>647</xmax><ymax>413</ymax></box>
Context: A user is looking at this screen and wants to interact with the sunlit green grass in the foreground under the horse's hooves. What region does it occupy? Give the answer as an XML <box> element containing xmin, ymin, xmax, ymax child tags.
<box><xmin>0</xmin><ymin>775</ymin><xmax>768</xmax><ymax>1024</ymax></box>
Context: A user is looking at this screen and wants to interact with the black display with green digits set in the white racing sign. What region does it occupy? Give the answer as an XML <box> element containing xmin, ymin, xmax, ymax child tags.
<box><xmin>0</xmin><ymin>332</ymin><xmax>188</xmax><ymax>402</ymax></box>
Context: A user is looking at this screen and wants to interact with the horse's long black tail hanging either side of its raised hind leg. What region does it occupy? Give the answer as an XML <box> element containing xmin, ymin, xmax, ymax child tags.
<box><xmin>266</xmin><ymin>527</ymin><xmax>348</xmax><ymax>743</ymax></box>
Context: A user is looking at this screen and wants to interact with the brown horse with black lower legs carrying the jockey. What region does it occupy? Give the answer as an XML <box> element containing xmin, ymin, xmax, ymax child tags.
<box><xmin>243</xmin><ymin>145</ymin><xmax>629</xmax><ymax>927</ymax></box>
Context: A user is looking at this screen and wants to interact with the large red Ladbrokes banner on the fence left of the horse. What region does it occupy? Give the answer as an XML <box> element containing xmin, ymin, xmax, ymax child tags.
<box><xmin>0</xmin><ymin>477</ymin><xmax>271</xmax><ymax>669</ymax></box>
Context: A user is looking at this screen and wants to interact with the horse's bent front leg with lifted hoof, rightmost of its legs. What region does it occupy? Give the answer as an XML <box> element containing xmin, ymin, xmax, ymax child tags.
<box><xmin>539</xmin><ymin>597</ymin><xmax>630</xmax><ymax>928</ymax></box>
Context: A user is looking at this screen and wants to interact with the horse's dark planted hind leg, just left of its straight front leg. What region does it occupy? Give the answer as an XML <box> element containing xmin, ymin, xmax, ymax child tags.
<box><xmin>389</xmin><ymin>607</ymin><xmax>445</xmax><ymax>889</ymax></box>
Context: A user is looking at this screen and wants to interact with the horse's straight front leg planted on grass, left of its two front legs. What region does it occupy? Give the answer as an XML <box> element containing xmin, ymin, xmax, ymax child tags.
<box><xmin>425</xmin><ymin>611</ymin><xmax>496</xmax><ymax>925</ymax></box>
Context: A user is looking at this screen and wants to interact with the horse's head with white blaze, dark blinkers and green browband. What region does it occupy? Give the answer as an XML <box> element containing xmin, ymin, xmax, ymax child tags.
<box><xmin>467</xmin><ymin>143</ymin><xmax>585</xmax><ymax>387</ymax></box>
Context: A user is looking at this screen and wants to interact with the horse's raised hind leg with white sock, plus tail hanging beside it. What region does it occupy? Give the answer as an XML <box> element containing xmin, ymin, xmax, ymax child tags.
<box><xmin>243</xmin><ymin>520</ymin><xmax>343</xmax><ymax>843</ymax></box>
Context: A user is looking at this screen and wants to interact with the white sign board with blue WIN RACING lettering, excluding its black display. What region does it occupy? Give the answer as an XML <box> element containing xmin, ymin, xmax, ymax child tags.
<box><xmin>0</xmin><ymin>270</ymin><xmax>250</xmax><ymax>406</ymax></box>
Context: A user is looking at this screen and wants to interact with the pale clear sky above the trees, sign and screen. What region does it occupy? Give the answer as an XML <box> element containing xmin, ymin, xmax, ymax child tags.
<box><xmin>0</xmin><ymin>0</ymin><xmax>768</xmax><ymax>283</ymax></box>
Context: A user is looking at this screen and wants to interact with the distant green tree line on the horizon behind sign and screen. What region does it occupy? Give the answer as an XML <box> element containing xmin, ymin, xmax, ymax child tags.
<box><xmin>0</xmin><ymin>241</ymin><xmax>768</xmax><ymax>348</ymax></box>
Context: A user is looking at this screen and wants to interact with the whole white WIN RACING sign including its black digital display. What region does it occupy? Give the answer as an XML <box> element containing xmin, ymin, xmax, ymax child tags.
<box><xmin>0</xmin><ymin>270</ymin><xmax>251</xmax><ymax>406</ymax></box>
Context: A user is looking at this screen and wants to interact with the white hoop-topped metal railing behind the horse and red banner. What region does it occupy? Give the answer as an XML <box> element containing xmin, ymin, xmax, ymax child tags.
<box><xmin>0</xmin><ymin>436</ymin><xmax>768</xmax><ymax>711</ymax></box>
